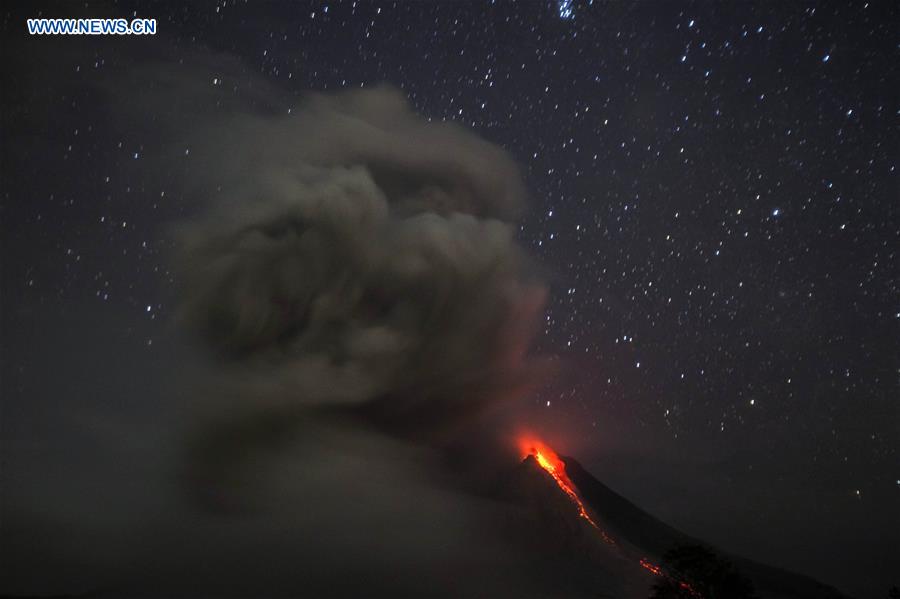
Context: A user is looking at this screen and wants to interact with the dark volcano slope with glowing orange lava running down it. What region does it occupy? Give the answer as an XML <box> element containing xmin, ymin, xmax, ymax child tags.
<box><xmin>515</xmin><ymin>443</ymin><xmax>847</xmax><ymax>599</ymax></box>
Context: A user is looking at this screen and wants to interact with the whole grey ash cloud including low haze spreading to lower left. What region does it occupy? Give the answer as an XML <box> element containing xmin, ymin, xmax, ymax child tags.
<box><xmin>0</xmin><ymin>45</ymin><xmax>564</xmax><ymax>597</ymax></box>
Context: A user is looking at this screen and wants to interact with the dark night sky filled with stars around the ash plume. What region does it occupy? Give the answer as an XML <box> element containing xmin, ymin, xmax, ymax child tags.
<box><xmin>0</xmin><ymin>0</ymin><xmax>900</xmax><ymax>596</ymax></box>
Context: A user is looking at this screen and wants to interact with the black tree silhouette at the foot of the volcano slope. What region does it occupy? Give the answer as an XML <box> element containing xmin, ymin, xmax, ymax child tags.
<box><xmin>650</xmin><ymin>545</ymin><xmax>756</xmax><ymax>599</ymax></box>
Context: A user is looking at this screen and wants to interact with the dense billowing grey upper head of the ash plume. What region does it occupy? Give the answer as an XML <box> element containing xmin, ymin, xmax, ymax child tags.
<box><xmin>172</xmin><ymin>88</ymin><xmax>542</xmax><ymax>442</ymax></box>
